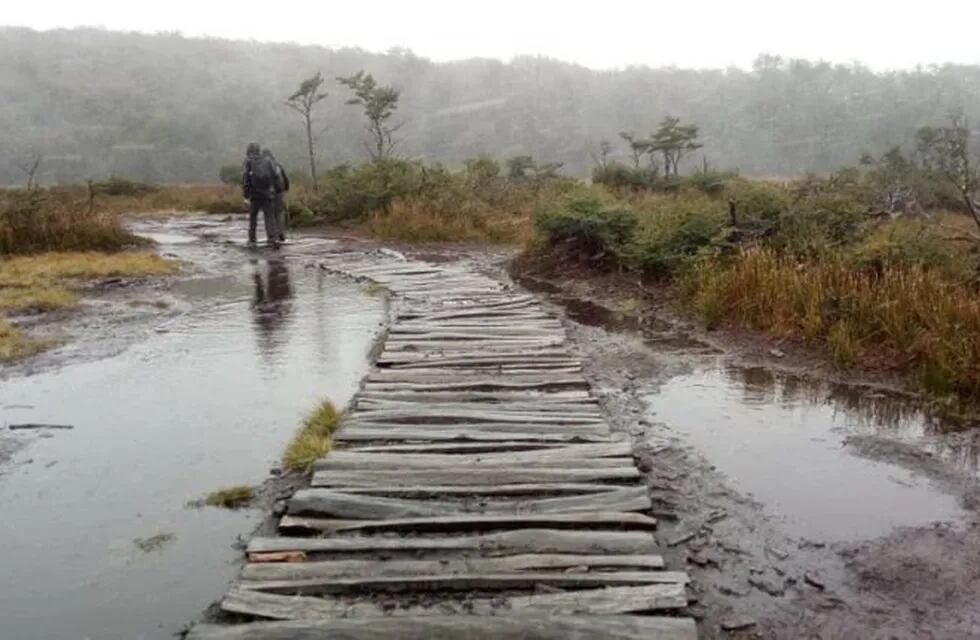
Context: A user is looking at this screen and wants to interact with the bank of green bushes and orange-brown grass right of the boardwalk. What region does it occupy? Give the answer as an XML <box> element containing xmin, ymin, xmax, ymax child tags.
<box><xmin>528</xmin><ymin>171</ymin><xmax>980</xmax><ymax>406</ymax></box>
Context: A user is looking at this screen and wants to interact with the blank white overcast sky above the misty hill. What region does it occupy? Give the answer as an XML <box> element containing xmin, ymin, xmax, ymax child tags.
<box><xmin>7</xmin><ymin>0</ymin><xmax>980</xmax><ymax>69</ymax></box>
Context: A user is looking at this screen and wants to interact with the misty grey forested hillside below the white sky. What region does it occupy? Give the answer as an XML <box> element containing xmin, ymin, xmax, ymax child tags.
<box><xmin>0</xmin><ymin>28</ymin><xmax>980</xmax><ymax>184</ymax></box>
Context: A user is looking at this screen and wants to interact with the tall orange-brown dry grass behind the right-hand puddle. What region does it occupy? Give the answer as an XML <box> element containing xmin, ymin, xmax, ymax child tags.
<box><xmin>684</xmin><ymin>250</ymin><xmax>980</xmax><ymax>402</ymax></box>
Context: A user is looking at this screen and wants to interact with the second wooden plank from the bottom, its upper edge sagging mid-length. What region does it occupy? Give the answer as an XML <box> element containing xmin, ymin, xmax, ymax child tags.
<box><xmin>221</xmin><ymin>583</ymin><xmax>687</xmax><ymax>620</ymax></box>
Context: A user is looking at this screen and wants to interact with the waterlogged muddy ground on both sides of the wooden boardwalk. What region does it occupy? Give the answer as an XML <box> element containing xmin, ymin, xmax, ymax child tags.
<box><xmin>0</xmin><ymin>220</ymin><xmax>980</xmax><ymax>639</ymax></box>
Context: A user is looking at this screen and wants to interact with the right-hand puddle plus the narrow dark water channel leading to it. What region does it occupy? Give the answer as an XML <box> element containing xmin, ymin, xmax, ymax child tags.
<box><xmin>557</xmin><ymin>297</ymin><xmax>980</xmax><ymax>541</ymax></box>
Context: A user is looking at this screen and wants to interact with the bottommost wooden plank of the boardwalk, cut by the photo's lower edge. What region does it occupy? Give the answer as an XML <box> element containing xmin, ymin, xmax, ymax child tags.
<box><xmin>187</xmin><ymin>612</ymin><xmax>697</xmax><ymax>640</ymax></box>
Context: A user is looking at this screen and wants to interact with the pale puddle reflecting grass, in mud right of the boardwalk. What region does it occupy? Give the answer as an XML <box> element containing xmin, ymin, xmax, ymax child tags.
<box><xmin>646</xmin><ymin>366</ymin><xmax>977</xmax><ymax>542</ymax></box>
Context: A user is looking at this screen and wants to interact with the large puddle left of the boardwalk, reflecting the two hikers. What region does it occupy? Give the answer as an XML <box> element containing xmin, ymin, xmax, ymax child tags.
<box><xmin>0</xmin><ymin>223</ymin><xmax>384</xmax><ymax>640</ymax></box>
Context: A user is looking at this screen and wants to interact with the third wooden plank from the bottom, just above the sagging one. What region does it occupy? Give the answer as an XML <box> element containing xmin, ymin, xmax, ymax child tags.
<box><xmin>238</xmin><ymin>571</ymin><xmax>688</xmax><ymax>596</ymax></box>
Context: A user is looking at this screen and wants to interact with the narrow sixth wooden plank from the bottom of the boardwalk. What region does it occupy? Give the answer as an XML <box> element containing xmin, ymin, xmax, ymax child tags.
<box><xmin>279</xmin><ymin>511</ymin><xmax>657</xmax><ymax>533</ymax></box>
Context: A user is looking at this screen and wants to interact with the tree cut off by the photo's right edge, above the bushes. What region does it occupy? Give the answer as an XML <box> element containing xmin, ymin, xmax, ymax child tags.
<box><xmin>915</xmin><ymin>113</ymin><xmax>980</xmax><ymax>228</ymax></box>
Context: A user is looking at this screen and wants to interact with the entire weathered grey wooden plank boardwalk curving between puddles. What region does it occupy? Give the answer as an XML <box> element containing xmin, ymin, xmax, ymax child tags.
<box><xmin>188</xmin><ymin>252</ymin><xmax>696</xmax><ymax>640</ymax></box>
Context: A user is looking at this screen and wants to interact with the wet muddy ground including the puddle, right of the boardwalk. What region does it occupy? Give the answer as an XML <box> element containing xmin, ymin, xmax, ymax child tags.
<box><xmin>514</xmin><ymin>252</ymin><xmax>980</xmax><ymax>639</ymax></box>
